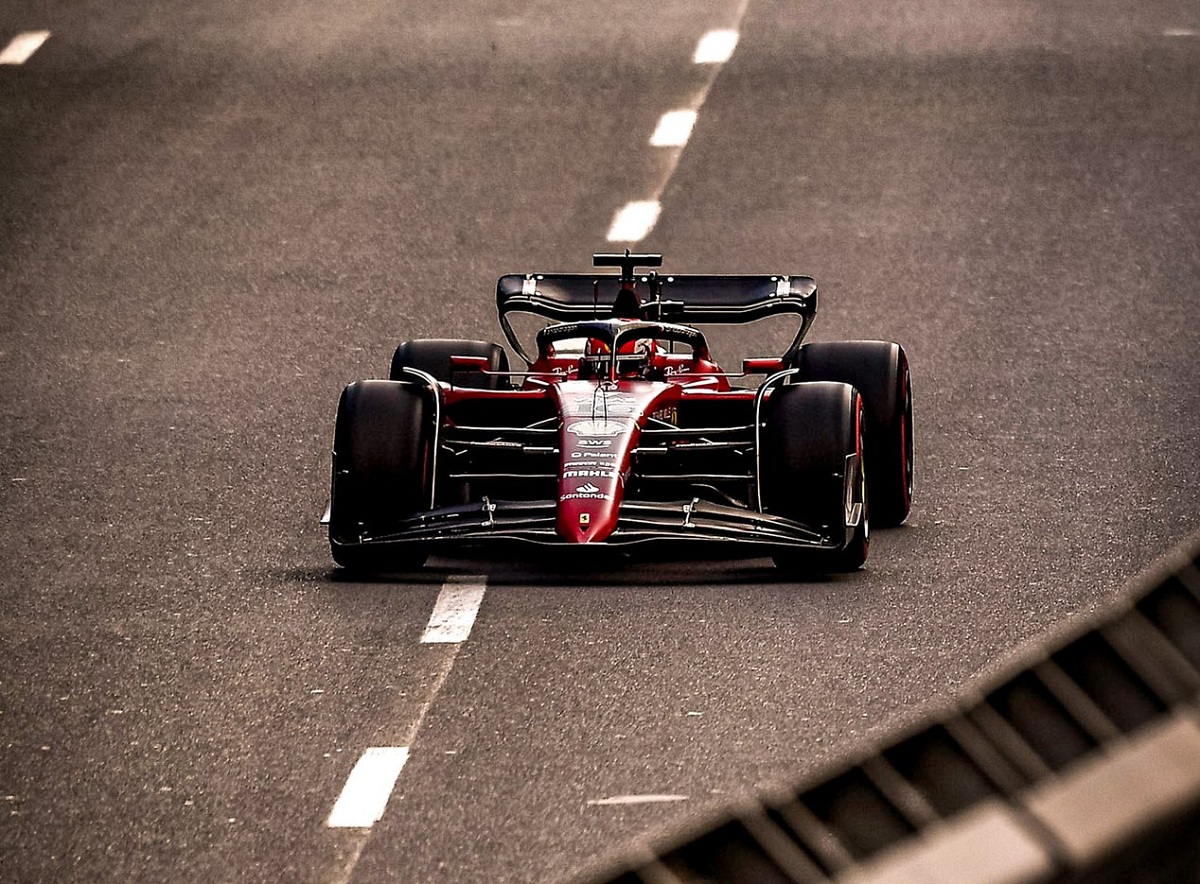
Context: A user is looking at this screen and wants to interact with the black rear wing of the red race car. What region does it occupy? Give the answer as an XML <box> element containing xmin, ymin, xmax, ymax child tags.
<box><xmin>496</xmin><ymin>273</ymin><xmax>817</xmax><ymax>363</ymax></box>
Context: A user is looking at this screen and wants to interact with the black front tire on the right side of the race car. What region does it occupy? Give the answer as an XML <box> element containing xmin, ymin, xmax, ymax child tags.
<box><xmin>761</xmin><ymin>383</ymin><xmax>870</xmax><ymax>572</ymax></box>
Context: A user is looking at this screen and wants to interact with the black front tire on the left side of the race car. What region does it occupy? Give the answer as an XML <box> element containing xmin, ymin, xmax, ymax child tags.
<box><xmin>329</xmin><ymin>380</ymin><xmax>432</xmax><ymax>571</ymax></box>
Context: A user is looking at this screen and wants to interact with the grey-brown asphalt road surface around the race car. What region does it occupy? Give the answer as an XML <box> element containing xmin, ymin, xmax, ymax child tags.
<box><xmin>0</xmin><ymin>0</ymin><xmax>1200</xmax><ymax>884</ymax></box>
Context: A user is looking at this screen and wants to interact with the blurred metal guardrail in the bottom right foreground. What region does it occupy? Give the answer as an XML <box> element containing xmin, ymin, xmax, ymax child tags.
<box><xmin>582</xmin><ymin>534</ymin><xmax>1200</xmax><ymax>884</ymax></box>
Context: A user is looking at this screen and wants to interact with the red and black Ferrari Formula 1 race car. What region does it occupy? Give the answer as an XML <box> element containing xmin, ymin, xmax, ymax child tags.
<box><xmin>326</xmin><ymin>251</ymin><xmax>913</xmax><ymax>572</ymax></box>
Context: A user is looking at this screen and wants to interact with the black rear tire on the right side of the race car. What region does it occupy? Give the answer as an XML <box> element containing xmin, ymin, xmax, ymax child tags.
<box><xmin>794</xmin><ymin>341</ymin><xmax>913</xmax><ymax>528</ymax></box>
